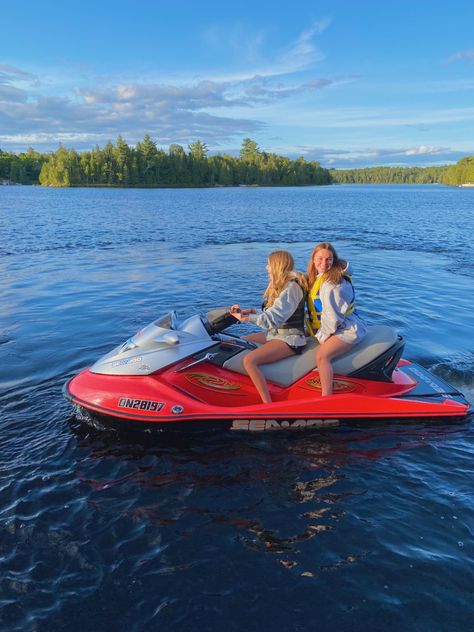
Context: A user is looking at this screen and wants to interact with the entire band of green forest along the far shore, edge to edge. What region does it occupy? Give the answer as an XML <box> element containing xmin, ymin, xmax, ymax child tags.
<box><xmin>0</xmin><ymin>134</ymin><xmax>474</xmax><ymax>187</ymax></box>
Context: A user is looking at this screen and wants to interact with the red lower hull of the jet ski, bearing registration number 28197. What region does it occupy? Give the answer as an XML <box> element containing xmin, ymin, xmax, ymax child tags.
<box><xmin>64</xmin><ymin>360</ymin><xmax>473</xmax><ymax>432</ymax></box>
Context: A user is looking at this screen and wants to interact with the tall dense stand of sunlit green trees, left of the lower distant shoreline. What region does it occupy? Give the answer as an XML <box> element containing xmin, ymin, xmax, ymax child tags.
<box><xmin>39</xmin><ymin>134</ymin><xmax>330</xmax><ymax>187</ymax></box>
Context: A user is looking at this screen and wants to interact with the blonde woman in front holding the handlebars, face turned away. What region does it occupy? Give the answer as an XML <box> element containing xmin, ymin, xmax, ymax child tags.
<box><xmin>230</xmin><ymin>250</ymin><xmax>307</xmax><ymax>404</ymax></box>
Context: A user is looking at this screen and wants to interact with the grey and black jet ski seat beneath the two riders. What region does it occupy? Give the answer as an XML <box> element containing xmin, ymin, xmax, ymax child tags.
<box><xmin>223</xmin><ymin>325</ymin><xmax>399</xmax><ymax>387</ymax></box>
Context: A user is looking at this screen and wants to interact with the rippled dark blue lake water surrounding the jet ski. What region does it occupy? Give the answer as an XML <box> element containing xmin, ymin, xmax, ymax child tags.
<box><xmin>0</xmin><ymin>186</ymin><xmax>474</xmax><ymax>632</ymax></box>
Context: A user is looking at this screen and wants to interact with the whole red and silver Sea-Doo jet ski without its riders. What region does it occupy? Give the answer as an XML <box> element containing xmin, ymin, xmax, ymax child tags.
<box><xmin>64</xmin><ymin>308</ymin><xmax>474</xmax><ymax>431</ymax></box>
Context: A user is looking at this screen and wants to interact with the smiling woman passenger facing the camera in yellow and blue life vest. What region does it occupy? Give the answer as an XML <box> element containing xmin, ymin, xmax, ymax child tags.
<box><xmin>306</xmin><ymin>242</ymin><xmax>367</xmax><ymax>395</ymax></box>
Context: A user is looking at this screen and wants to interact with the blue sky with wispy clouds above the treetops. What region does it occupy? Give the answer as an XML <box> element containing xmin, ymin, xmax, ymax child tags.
<box><xmin>0</xmin><ymin>0</ymin><xmax>474</xmax><ymax>168</ymax></box>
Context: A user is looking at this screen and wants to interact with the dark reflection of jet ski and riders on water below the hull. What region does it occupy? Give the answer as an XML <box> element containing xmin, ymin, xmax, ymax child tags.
<box><xmin>66</xmin><ymin>424</ymin><xmax>465</xmax><ymax>577</ymax></box>
